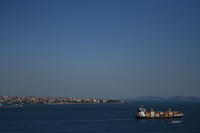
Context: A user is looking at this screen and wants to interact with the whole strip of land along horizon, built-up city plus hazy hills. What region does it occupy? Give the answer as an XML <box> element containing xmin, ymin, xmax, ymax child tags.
<box><xmin>0</xmin><ymin>96</ymin><xmax>200</xmax><ymax>107</ymax></box>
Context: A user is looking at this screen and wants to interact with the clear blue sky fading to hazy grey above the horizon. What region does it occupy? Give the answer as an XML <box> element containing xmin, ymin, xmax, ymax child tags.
<box><xmin>0</xmin><ymin>0</ymin><xmax>200</xmax><ymax>98</ymax></box>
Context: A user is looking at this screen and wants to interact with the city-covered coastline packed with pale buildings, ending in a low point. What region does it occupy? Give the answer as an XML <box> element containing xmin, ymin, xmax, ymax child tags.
<box><xmin>0</xmin><ymin>96</ymin><xmax>123</xmax><ymax>105</ymax></box>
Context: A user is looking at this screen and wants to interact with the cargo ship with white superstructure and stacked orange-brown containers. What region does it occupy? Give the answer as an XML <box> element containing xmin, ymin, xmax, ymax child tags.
<box><xmin>135</xmin><ymin>106</ymin><xmax>184</xmax><ymax>119</ymax></box>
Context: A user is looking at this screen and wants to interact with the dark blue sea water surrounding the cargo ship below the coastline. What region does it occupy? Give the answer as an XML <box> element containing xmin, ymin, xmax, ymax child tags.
<box><xmin>0</xmin><ymin>103</ymin><xmax>200</xmax><ymax>133</ymax></box>
